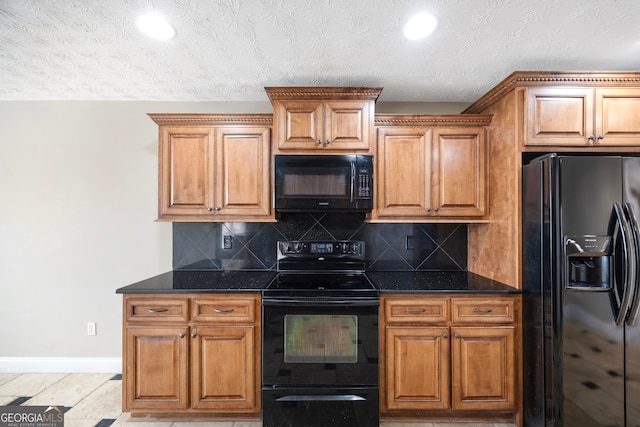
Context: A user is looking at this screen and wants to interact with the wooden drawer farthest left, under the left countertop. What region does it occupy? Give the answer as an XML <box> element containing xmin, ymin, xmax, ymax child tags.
<box><xmin>124</xmin><ymin>297</ymin><xmax>189</xmax><ymax>322</ymax></box>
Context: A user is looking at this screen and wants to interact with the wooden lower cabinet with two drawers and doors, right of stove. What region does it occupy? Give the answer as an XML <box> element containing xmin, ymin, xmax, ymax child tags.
<box><xmin>380</xmin><ymin>295</ymin><xmax>521</xmax><ymax>424</ymax></box>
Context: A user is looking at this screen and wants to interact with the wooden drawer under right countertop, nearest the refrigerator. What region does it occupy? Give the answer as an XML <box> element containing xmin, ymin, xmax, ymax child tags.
<box><xmin>451</xmin><ymin>298</ymin><xmax>516</xmax><ymax>323</ymax></box>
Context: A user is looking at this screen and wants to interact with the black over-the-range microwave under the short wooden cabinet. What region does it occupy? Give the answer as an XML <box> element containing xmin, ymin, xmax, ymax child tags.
<box><xmin>274</xmin><ymin>154</ymin><xmax>373</xmax><ymax>212</ymax></box>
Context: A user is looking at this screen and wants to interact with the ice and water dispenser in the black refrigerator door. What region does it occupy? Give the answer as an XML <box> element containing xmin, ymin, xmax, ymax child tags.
<box><xmin>564</xmin><ymin>235</ymin><xmax>611</xmax><ymax>291</ymax></box>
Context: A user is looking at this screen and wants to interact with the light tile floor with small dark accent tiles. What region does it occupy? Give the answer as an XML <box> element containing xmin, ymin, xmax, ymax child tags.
<box><xmin>0</xmin><ymin>373</ymin><xmax>513</xmax><ymax>427</ymax></box>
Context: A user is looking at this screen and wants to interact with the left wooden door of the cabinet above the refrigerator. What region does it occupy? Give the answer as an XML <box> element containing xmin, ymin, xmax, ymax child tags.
<box><xmin>525</xmin><ymin>87</ymin><xmax>594</xmax><ymax>146</ymax></box>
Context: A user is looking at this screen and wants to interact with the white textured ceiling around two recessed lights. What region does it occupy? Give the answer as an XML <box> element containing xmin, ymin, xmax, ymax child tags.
<box><xmin>0</xmin><ymin>0</ymin><xmax>640</xmax><ymax>102</ymax></box>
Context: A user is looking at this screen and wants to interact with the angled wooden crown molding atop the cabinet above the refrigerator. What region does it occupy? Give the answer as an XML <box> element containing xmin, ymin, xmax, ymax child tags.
<box><xmin>462</xmin><ymin>71</ymin><xmax>640</xmax><ymax>114</ymax></box>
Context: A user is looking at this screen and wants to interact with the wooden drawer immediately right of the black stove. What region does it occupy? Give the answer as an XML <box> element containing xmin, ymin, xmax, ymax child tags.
<box><xmin>384</xmin><ymin>298</ymin><xmax>449</xmax><ymax>323</ymax></box>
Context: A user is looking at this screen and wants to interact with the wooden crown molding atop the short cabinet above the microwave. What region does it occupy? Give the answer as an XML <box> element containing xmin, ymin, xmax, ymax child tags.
<box><xmin>264</xmin><ymin>86</ymin><xmax>382</xmax><ymax>104</ymax></box>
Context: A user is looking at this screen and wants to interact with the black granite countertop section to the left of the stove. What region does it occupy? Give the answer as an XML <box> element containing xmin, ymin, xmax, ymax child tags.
<box><xmin>116</xmin><ymin>270</ymin><xmax>276</xmax><ymax>294</ymax></box>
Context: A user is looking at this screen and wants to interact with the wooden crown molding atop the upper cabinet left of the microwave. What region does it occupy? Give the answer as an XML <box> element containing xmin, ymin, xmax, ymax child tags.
<box><xmin>148</xmin><ymin>113</ymin><xmax>273</xmax><ymax>126</ymax></box>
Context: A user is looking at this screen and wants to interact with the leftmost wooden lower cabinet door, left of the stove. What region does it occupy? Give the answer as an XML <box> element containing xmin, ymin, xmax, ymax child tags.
<box><xmin>123</xmin><ymin>325</ymin><xmax>189</xmax><ymax>411</ymax></box>
